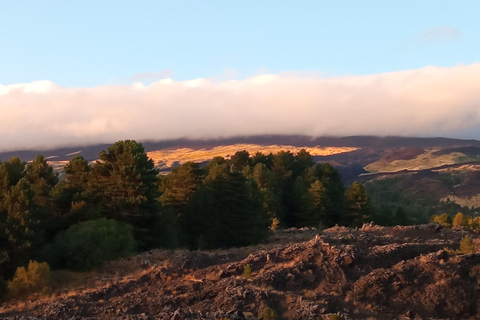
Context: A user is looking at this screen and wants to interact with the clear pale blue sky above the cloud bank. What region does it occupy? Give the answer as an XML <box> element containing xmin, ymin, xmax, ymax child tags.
<box><xmin>0</xmin><ymin>0</ymin><xmax>480</xmax><ymax>87</ymax></box>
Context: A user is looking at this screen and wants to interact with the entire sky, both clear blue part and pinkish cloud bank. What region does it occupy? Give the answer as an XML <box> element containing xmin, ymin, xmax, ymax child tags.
<box><xmin>0</xmin><ymin>0</ymin><xmax>480</xmax><ymax>151</ymax></box>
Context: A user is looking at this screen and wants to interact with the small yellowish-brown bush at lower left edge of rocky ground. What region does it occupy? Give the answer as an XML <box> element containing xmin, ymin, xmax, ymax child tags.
<box><xmin>8</xmin><ymin>261</ymin><xmax>50</xmax><ymax>298</ymax></box>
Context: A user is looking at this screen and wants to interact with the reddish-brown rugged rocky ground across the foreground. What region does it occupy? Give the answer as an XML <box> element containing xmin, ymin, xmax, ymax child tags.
<box><xmin>0</xmin><ymin>224</ymin><xmax>480</xmax><ymax>320</ymax></box>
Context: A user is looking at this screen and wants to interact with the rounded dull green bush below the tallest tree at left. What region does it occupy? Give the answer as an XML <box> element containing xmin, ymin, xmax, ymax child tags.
<box><xmin>45</xmin><ymin>218</ymin><xmax>136</xmax><ymax>270</ymax></box>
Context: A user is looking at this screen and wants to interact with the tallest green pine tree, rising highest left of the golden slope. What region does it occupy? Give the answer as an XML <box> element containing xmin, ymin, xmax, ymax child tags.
<box><xmin>89</xmin><ymin>140</ymin><xmax>161</xmax><ymax>250</ymax></box>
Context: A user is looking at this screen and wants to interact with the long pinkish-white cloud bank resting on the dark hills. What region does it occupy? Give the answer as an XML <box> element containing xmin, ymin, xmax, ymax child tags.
<box><xmin>0</xmin><ymin>64</ymin><xmax>480</xmax><ymax>151</ymax></box>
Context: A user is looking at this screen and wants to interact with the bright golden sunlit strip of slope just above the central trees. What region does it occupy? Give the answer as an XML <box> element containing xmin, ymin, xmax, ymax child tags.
<box><xmin>147</xmin><ymin>144</ymin><xmax>358</xmax><ymax>169</ymax></box>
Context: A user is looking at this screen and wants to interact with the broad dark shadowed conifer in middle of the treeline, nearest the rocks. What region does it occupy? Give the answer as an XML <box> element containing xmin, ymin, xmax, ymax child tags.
<box><xmin>180</xmin><ymin>171</ymin><xmax>270</xmax><ymax>248</ymax></box>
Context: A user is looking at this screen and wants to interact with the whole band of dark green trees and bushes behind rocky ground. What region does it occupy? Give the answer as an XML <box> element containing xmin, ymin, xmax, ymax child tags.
<box><xmin>0</xmin><ymin>140</ymin><xmax>370</xmax><ymax>298</ymax></box>
